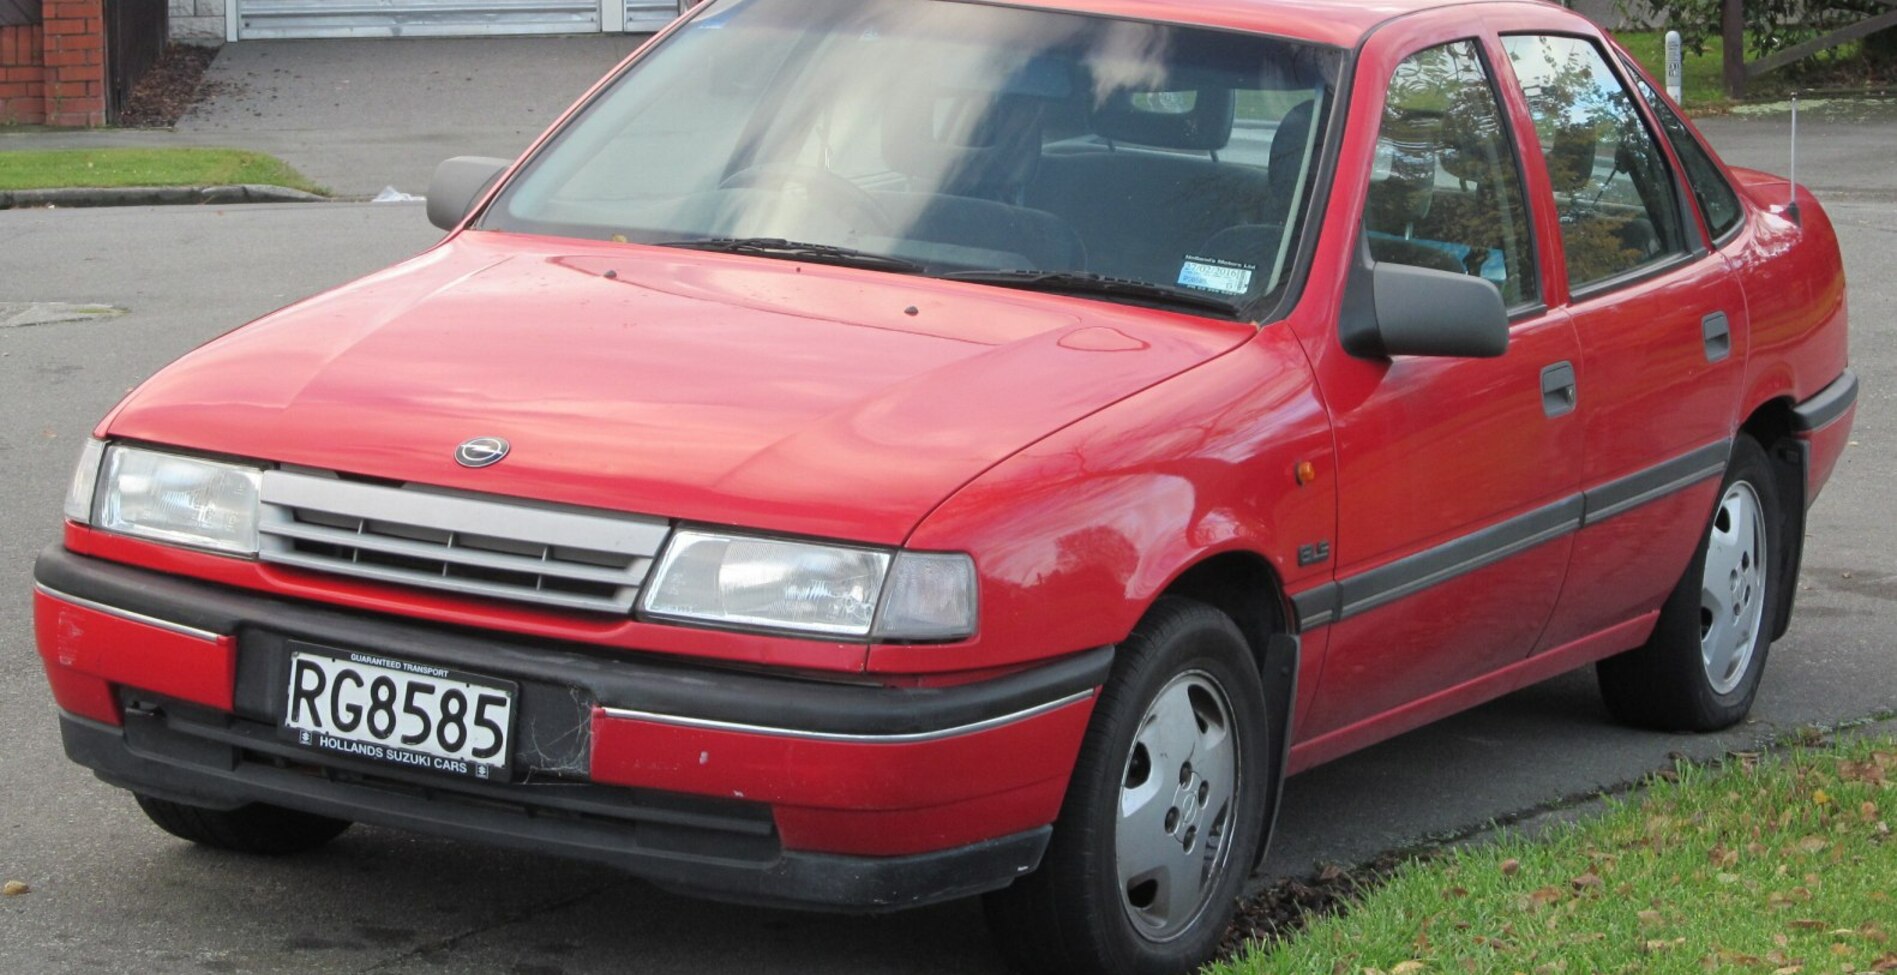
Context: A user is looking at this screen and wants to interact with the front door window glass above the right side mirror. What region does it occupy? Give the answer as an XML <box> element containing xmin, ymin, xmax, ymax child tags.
<box><xmin>1364</xmin><ymin>40</ymin><xmax>1537</xmax><ymax>307</ymax></box>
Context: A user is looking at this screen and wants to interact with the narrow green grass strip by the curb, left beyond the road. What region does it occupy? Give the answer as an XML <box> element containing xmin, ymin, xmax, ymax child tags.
<box><xmin>0</xmin><ymin>148</ymin><xmax>322</xmax><ymax>193</ymax></box>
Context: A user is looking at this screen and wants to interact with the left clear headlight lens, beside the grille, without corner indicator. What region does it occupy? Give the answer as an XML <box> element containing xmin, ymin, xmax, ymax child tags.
<box><xmin>97</xmin><ymin>446</ymin><xmax>264</xmax><ymax>556</ymax></box>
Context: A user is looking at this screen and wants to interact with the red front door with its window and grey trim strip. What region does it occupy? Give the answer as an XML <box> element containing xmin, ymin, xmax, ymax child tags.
<box><xmin>1299</xmin><ymin>26</ymin><xmax>1582</xmax><ymax>743</ymax></box>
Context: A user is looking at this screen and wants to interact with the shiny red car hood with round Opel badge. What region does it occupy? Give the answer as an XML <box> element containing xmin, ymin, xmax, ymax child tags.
<box><xmin>101</xmin><ymin>233</ymin><xmax>1252</xmax><ymax>544</ymax></box>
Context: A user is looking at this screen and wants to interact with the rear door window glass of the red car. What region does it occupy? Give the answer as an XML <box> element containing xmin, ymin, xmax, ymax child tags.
<box><xmin>1502</xmin><ymin>36</ymin><xmax>1686</xmax><ymax>290</ymax></box>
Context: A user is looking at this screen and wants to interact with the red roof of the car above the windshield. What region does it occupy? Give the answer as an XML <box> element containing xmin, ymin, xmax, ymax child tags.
<box><xmin>1002</xmin><ymin>0</ymin><xmax>1588</xmax><ymax>47</ymax></box>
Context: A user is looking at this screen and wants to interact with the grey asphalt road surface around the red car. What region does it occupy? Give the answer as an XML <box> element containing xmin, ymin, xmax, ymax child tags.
<box><xmin>0</xmin><ymin>116</ymin><xmax>1897</xmax><ymax>975</ymax></box>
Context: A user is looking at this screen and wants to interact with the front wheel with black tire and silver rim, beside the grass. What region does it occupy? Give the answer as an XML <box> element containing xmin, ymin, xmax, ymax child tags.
<box><xmin>985</xmin><ymin>598</ymin><xmax>1273</xmax><ymax>975</ymax></box>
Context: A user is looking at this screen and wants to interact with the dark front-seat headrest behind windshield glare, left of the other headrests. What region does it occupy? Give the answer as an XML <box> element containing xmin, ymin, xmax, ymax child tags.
<box><xmin>882</xmin><ymin>89</ymin><xmax>1043</xmax><ymax>199</ymax></box>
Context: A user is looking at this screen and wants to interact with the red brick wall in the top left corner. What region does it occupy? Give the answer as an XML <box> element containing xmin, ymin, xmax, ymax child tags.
<box><xmin>0</xmin><ymin>0</ymin><xmax>106</xmax><ymax>127</ymax></box>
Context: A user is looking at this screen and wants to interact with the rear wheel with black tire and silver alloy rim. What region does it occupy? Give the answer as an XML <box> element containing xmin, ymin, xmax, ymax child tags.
<box><xmin>1595</xmin><ymin>436</ymin><xmax>1802</xmax><ymax>732</ymax></box>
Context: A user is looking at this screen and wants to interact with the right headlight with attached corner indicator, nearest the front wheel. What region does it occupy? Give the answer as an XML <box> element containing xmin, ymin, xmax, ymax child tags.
<box><xmin>645</xmin><ymin>529</ymin><xmax>975</xmax><ymax>641</ymax></box>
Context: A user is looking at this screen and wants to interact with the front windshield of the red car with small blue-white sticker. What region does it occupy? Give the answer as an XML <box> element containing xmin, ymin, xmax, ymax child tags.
<box><xmin>480</xmin><ymin>0</ymin><xmax>1339</xmax><ymax>313</ymax></box>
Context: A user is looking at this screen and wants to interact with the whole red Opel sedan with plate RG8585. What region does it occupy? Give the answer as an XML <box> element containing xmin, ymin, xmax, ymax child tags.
<box><xmin>34</xmin><ymin>0</ymin><xmax>1857</xmax><ymax>973</ymax></box>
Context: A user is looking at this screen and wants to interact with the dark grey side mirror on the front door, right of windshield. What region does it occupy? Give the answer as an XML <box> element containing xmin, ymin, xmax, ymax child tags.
<box><xmin>1339</xmin><ymin>262</ymin><xmax>1508</xmax><ymax>359</ymax></box>
